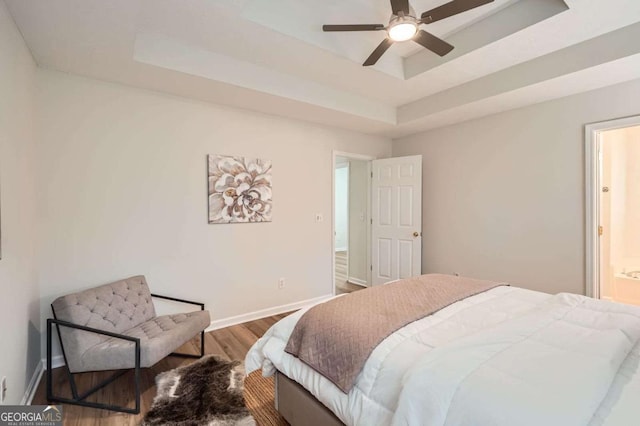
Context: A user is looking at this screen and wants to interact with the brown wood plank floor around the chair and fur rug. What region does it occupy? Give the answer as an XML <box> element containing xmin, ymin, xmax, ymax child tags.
<box><xmin>32</xmin><ymin>312</ymin><xmax>290</xmax><ymax>426</ymax></box>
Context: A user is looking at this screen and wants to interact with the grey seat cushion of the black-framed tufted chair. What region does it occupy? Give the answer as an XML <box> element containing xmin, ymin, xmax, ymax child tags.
<box><xmin>71</xmin><ymin>311</ymin><xmax>211</xmax><ymax>373</ymax></box>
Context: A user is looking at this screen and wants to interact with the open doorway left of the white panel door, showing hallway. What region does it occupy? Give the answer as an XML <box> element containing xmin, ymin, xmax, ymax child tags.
<box><xmin>333</xmin><ymin>153</ymin><xmax>371</xmax><ymax>294</ymax></box>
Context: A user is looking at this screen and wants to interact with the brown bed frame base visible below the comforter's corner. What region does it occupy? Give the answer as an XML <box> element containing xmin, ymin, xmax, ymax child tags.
<box><xmin>275</xmin><ymin>371</ymin><xmax>344</xmax><ymax>426</ymax></box>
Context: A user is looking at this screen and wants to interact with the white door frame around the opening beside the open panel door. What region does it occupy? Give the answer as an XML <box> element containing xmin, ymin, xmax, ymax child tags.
<box><xmin>330</xmin><ymin>150</ymin><xmax>377</xmax><ymax>296</ymax></box>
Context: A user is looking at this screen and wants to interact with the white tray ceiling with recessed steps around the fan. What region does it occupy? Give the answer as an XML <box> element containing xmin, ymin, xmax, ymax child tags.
<box><xmin>5</xmin><ymin>0</ymin><xmax>640</xmax><ymax>137</ymax></box>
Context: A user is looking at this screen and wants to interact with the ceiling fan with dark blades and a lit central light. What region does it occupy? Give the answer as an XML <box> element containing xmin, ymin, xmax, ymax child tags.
<box><xmin>322</xmin><ymin>0</ymin><xmax>493</xmax><ymax>67</ymax></box>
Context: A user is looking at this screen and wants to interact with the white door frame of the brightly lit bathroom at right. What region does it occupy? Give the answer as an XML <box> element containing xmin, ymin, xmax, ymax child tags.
<box><xmin>584</xmin><ymin>115</ymin><xmax>640</xmax><ymax>299</ymax></box>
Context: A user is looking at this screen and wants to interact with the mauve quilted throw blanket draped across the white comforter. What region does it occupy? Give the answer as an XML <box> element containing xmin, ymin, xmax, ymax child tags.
<box><xmin>285</xmin><ymin>274</ymin><xmax>507</xmax><ymax>393</ymax></box>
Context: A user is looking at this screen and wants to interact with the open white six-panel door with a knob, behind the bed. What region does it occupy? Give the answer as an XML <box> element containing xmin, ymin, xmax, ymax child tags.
<box><xmin>371</xmin><ymin>155</ymin><xmax>422</xmax><ymax>285</ymax></box>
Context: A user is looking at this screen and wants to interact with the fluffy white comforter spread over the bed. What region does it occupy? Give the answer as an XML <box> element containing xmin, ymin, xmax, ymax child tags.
<box><xmin>246</xmin><ymin>287</ymin><xmax>640</xmax><ymax>426</ymax></box>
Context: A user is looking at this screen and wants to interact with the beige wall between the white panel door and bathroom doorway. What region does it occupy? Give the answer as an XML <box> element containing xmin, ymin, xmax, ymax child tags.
<box><xmin>393</xmin><ymin>80</ymin><xmax>640</xmax><ymax>293</ymax></box>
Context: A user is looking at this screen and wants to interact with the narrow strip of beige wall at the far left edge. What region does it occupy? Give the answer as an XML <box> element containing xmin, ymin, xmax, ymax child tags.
<box><xmin>0</xmin><ymin>1</ymin><xmax>40</xmax><ymax>404</ymax></box>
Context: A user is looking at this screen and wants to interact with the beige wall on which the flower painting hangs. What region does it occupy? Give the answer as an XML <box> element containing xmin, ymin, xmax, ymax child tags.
<box><xmin>38</xmin><ymin>70</ymin><xmax>391</xmax><ymax>354</ymax></box>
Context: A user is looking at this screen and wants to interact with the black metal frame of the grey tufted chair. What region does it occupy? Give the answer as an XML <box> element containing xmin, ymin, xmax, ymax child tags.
<box><xmin>47</xmin><ymin>294</ymin><xmax>204</xmax><ymax>414</ymax></box>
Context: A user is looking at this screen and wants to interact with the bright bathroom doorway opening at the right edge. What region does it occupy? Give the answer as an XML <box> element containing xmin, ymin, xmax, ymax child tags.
<box><xmin>587</xmin><ymin>117</ymin><xmax>640</xmax><ymax>306</ymax></box>
